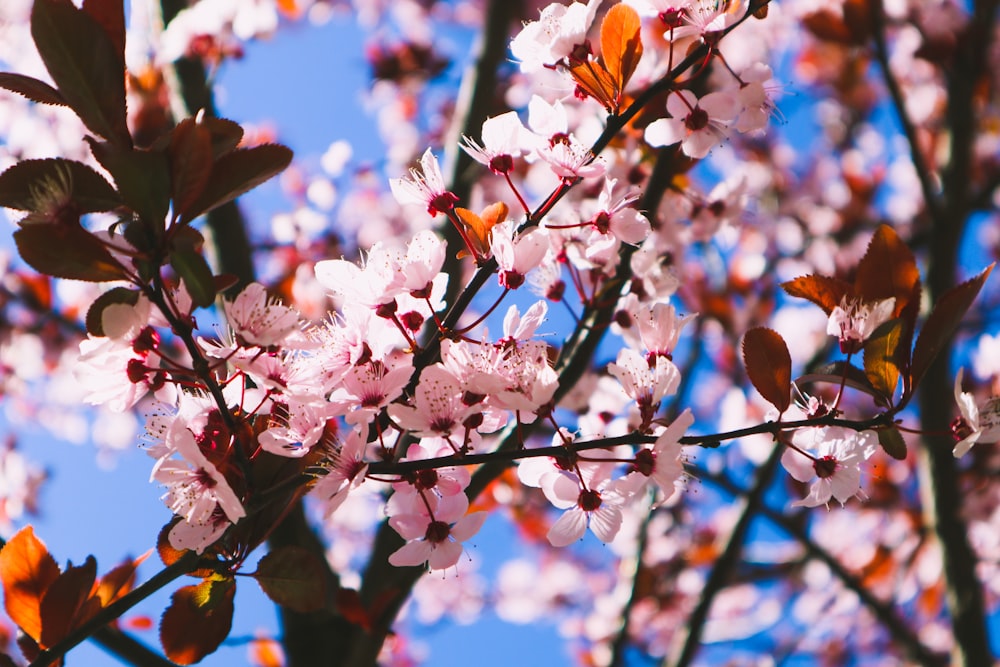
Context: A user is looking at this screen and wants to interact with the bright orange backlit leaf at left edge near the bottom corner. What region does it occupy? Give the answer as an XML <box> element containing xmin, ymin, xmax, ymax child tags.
<box><xmin>0</xmin><ymin>526</ymin><xmax>59</xmax><ymax>640</ymax></box>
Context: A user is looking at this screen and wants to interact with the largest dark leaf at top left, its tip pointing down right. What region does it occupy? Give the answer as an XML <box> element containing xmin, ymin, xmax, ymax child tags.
<box><xmin>31</xmin><ymin>0</ymin><xmax>132</xmax><ymax>146</ymax></box>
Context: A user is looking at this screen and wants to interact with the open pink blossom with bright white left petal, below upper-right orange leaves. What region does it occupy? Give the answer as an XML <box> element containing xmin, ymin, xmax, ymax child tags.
<box><xmin>646</xmin><ymin>90</ymin><xmax>739</xmax><ymax>158</ymax></box>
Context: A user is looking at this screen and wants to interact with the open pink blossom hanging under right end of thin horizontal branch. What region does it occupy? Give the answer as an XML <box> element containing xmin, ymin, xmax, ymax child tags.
<box><xmin>781</xmin><ymin>426</ymin><xmax>878</xmax><ymax>507</ymax></box>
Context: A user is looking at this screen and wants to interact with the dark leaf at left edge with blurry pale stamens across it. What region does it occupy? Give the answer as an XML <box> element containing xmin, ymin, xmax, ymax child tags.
<box><xmin>0</xmin><ymin>158</ymin><xmax>122</xmax><ymax>213</ymax></box>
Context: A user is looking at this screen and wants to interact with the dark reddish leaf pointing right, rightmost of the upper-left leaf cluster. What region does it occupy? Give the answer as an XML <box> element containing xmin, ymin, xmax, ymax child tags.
<box><xmin>182</xmin><ymin>144</ymin><xmax>292</xmax><ymax>222</ymax></box>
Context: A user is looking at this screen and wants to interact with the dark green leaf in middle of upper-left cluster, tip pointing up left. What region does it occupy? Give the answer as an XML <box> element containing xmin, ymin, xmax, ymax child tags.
<box><xmin>89</xmin><ymin>141</ymin><xmax>170</xmax><ymax>238</ymax></box>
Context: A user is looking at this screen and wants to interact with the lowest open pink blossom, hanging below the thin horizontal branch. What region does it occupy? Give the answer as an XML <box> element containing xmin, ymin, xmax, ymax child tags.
<box><xmin>387</xmin><ymin>493</ymin><xmax>486</xmax><ymax>570</ymax></box>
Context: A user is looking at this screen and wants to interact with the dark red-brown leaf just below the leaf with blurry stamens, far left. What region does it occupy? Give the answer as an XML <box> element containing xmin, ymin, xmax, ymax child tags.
<box><xmin>14</xmin><ymin>222</ymin><xmax>125</xmax><ymax>282</ymax></box>
